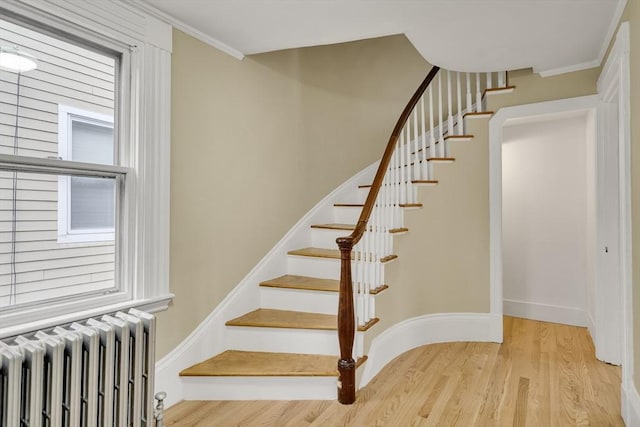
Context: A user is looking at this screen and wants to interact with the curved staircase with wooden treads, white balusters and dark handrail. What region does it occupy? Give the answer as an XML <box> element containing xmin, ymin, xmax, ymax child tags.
<box><xmin>180</xmin><ymin>67</ymin><xmax>513</xmax><ymax>403</ymax></box>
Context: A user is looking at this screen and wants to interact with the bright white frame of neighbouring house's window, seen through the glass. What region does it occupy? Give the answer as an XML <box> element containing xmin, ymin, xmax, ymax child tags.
<box><xmin>58</xmin><ymin>104</ymin><xmax>115</xmax><ymax>243</ymax></box>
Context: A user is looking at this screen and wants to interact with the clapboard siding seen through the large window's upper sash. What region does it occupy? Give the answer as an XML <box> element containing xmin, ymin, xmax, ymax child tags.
<box><xmin>0</xmin><ymin>19</ymin><xmax>117</xmax><ymax>163</ymax></box>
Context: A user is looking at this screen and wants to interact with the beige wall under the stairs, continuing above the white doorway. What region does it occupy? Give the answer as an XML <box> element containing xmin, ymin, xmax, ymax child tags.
<box><xmin>367</xmin><ymin>69</ymin><xmax>599</xmax><ymax>342</ymax></box>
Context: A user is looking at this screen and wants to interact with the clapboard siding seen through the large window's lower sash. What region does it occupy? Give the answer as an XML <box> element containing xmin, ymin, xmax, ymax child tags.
<box><xmin>0</xmin><ymin>171</ymin><xmax>117</xmax><ymax>311</ymax></box>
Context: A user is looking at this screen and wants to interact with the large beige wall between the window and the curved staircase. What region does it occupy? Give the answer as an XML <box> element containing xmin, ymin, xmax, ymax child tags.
<box><xmin>157</xmin><ymin>31</ymin><xmax>429</xmax><ymax>357</ymax></box>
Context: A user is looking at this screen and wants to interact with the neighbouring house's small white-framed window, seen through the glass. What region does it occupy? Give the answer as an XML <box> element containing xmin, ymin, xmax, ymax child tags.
<box><xmin>58</xmin><ymin>104</ymin><xmax>116</xmax><ymax>243</ymax></box>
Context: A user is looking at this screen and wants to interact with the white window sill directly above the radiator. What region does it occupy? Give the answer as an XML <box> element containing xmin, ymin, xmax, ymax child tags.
<box><xmin>0</xmin><ymin>294</ymin><xmax>174</xmax><ymax>339</ymax></box>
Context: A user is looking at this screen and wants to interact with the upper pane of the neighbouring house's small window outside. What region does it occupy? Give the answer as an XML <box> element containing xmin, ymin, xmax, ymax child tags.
<box><xmin>71</xmin><ymin>119</ymin><xmax>113</xmax><ymax>165</ymax></box>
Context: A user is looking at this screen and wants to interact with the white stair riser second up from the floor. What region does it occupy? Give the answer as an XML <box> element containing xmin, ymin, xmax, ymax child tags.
<box><xmin>225</xmin><ymin>326</ymin><xmax>340</xmax><ymax>355</ymax></box>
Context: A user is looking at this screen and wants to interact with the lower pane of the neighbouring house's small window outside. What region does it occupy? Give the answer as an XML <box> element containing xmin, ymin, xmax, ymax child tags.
<box><xmin>71</xmin><ymin>177</ymin><xmax>116</xmax><ymax>231</ymax></box>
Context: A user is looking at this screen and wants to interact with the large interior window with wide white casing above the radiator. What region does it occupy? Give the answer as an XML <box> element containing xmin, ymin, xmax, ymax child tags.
<box><xmin>0</xmin><ymin>0</ymin><xmax>172</xmax><ymax>338</ymax></box>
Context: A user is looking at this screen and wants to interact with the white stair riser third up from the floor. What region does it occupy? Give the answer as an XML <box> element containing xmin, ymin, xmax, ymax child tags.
<box><xmin>260</xmin><ymin>286</ymin><xmax>338</xmax><ymax>314</ymax></box>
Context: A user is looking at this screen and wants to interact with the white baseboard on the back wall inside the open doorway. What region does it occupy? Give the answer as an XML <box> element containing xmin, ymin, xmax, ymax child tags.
<box><xmin>503</xmin><ymin>299</ymin><xmax>589</xmax><ymax>327</ymax></box>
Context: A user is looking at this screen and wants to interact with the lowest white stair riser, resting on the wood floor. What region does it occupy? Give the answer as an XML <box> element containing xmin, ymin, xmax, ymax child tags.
<box><xmin>182</xmin><ymin>378</ymin><xmax>337</xmax><ymax>400</ymax></box>
